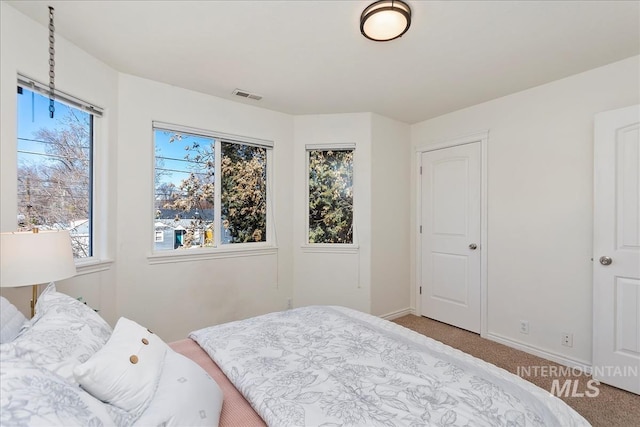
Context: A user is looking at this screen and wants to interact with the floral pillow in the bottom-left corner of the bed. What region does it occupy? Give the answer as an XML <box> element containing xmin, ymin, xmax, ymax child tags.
<box><xmin>0</xmin><ymin>353</ymin><xmax>114</xmax><ymax>427</ymax></box>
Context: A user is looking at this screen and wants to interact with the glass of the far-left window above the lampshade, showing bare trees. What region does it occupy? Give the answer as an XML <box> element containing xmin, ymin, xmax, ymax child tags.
<box><xmin>17</xmin><ymin>86</ymin><xmax>93</xmax><ymax>258</ymax></box>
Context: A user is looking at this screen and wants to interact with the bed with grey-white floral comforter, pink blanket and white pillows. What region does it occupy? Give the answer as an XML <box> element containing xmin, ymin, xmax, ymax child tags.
<box><xmin>0</xmin><ymin>285</ymin><xmax>588</xmax><ymax>427</ymax></box>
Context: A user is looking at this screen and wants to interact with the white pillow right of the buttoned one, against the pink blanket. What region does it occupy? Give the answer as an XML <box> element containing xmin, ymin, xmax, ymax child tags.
<box><xmin>134</xmin><ymin>349</ymin><xmax>223</xmax><ymax>427</ymax></box>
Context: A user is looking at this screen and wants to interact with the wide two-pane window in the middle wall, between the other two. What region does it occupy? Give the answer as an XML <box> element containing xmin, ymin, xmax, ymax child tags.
<box><xmin>154</xmin><ymin>123</ymin><xmax>272</xmax><ymax>251</ymax></box>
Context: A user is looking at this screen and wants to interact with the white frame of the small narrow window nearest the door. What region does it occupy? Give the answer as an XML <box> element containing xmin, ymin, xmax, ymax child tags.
<box><xmin>302</xmin><ymin>143</ymin><xmax>359</xmax><ymax>253</ymax></box>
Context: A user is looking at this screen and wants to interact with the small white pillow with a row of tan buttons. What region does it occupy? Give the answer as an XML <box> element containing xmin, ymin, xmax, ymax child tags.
<box><xmin>73</xmin><ymin>317</ymin><xmax>169</xmax><ymax>417</ymax></box>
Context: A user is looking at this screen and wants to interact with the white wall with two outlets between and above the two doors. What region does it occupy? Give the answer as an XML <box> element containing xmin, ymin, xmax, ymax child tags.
<box><xmin>411</xmin><ymin>57</ymin><xmax>640</xmax><ymax>365</ymax></box>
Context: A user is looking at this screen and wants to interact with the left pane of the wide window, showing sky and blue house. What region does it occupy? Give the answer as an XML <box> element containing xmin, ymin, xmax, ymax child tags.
<box><xmin>154</xmin><ymin>129</ymin><xmax>215</xmax><ymax>251</ymax></box>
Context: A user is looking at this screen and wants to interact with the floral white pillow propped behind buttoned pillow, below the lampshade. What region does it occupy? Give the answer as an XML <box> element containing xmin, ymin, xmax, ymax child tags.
<box><xmin>0</xmin><ymin>283</ymin><xmax>111</xmax><ymax>382</ymax></box>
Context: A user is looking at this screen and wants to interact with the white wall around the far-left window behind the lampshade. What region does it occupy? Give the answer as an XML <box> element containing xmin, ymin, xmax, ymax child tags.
<box><xmin>0</xmin><ymin>2</ymin><xmax>118</xmax><ymax>321</ymax></box>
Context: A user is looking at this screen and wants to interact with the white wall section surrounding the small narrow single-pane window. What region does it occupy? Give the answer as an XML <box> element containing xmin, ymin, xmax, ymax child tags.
<box><xmin>293</xmin><ymin>113</ymin><xmax>371</xmax><ymax>312</ymax></box>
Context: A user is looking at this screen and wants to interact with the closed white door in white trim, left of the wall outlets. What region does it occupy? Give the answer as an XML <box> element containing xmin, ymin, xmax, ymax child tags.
<box><xmin>420</xmin><ymin>142</ymin><xmax>482</xmax><ymax>333</ymax></box>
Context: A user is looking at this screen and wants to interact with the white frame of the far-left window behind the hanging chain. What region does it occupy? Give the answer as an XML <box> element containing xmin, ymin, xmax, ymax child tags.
<box><xmin>17</xmin><ymin>74</ymin><xmax>113</xmax><ymax>275</ymax></box>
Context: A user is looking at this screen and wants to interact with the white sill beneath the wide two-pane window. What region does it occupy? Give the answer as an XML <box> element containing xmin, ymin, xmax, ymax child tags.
<box><xmin>147</xmin><ymin>246</ymin><xmax>278</xmax><ymax>265</ymax></box>
